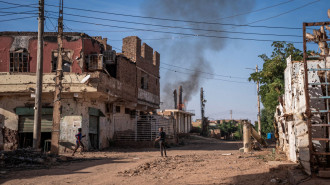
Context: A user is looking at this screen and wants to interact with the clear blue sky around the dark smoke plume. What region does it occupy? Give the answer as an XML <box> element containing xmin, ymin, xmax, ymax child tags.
<box><xmin>0</xmin><ymin>0</ymin><xmax>330</xmax><ymax>121</ymax></box>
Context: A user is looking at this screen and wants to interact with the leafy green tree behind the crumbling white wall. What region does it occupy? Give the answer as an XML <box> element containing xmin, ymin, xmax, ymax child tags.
<box><xmin>249</xmin><ymin>41</ymin><xmax>303</xmax><ymax>136</ymax></box>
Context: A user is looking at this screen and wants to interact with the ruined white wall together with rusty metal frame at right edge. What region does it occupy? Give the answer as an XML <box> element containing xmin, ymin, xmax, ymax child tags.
<box><xmin>274</xmin><ymin>19</ymin><xmax>330</xmax><ymax>177</ymax></box>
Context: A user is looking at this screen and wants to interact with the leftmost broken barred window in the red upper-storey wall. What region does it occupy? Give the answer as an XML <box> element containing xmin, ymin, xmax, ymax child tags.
<box><xmin>9</xmin><ymin>50</ymin><xmax>30</xmax><ymax>72</ymax></box>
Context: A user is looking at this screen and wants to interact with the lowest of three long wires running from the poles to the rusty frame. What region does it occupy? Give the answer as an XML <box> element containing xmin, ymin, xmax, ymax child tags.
<box><xmin>48</xmin><ymin>17</ymin><xmax>302</xmax><ymax>43</ymax></box>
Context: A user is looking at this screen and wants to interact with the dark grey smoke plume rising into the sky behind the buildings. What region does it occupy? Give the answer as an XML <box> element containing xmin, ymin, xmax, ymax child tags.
<box><xmin>142</xmin><ymin>0</ymin><xmax>255</xmax><ymax>109</ymax></box>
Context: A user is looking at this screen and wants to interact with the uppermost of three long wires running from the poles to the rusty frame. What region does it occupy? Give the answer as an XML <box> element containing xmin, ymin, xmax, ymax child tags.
<box><xmin>43</xmin><ymin>1</ymin><xmax>301</xmax><ymax>30</ymax></box>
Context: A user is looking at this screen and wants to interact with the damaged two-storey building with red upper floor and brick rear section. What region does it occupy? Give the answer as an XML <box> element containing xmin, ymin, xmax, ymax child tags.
<box><xmin>0</xmin><ymin>32</ymin><xmax>160</xmax><ymax>152</ymax></box>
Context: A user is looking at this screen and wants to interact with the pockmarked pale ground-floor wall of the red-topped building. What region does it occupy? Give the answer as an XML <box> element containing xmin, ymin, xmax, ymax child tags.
<box><xmin>0</xmin><ymin>93</ymin><xmax>113</xmax><ymax>152</ymax></box>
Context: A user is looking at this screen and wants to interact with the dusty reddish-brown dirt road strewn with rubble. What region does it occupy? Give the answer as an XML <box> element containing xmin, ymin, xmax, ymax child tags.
<box><xmin>0</xmin><ymin>137</ymin><xmax>324</xmax><ymax>185</ymax></box>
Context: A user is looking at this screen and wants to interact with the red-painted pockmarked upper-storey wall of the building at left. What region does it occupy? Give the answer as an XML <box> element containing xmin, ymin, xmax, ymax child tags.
<box><xmin>0</xmin><ymin>32</ymin><xmax>86</xmax><ymax>73</ymax></box>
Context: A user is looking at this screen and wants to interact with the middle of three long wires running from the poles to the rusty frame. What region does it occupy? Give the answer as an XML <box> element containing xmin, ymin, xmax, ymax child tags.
<box><xmin>48</xmin><ymin>11</ymin><xmax>302</xmax><ymax>38</ymax></box>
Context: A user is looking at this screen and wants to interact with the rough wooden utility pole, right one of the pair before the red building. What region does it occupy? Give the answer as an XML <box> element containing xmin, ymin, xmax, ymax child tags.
<box><xmin>51</xmin><ymin>0</ymin><xmax>63</xmax><ymax>155</ymax></box>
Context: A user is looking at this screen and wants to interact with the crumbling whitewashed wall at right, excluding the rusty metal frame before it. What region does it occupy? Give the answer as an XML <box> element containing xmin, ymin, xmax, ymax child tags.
<box><xmin>274</xmin><ymin>57</ymin><xmax>330</xmax><ymax>174</ymax></box>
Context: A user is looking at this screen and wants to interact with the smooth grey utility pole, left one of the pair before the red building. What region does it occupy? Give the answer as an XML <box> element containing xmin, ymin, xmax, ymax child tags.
<box><xmin>33</xmin><ymin>0</ymin><xmax>45</xmax><ymax>149</ymax></box>
